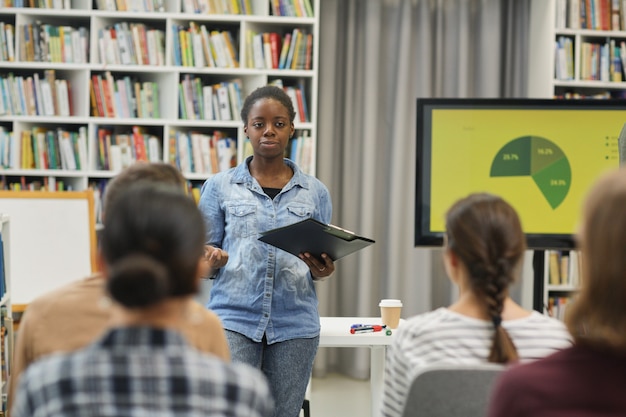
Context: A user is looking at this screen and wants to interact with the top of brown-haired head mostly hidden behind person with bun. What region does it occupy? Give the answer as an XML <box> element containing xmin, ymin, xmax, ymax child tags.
<box><xmin>103</xmin><ymin>162</ymin><xmax>186</xmax><ymax>214</ymax></box>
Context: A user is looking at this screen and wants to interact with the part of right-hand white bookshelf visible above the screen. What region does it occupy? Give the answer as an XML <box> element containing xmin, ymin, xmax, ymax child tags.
<box><xmin>529</xmin><ymin>0</ymin><xmax>626</xmax><ymax>98</ymax></box>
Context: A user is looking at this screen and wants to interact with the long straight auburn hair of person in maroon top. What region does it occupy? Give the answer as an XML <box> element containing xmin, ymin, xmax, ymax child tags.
<box><xmin>566</xmin><ymin>168</ymin><xmax>626</xmax><ymax>354</ymax></box>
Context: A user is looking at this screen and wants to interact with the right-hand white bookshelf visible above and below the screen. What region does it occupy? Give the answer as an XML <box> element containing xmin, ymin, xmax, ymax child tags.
<box><xmin>528</xmin><ymin>0</ymin><xmax>626</xmax><ymax>318</ymax></box>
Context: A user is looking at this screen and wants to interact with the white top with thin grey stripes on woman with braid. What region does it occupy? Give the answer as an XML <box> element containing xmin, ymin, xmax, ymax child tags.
<box><xmin>382</xmin><ymin>308</ymin><xmax>572</xmax><ymax>417</ymax></box>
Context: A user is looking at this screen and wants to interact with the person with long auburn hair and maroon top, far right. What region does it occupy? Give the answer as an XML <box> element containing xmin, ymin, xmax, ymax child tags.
<box><xmin>488</xmin><ymin>169</ymin><xmax>626</xmax><ymax>417</ymax></box>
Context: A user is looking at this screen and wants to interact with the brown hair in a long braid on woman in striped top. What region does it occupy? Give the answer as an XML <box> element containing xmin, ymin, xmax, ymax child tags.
<box><xmin>446</xmin><ymin>193</ymin><xmax>526</xmax><ymax>363</ymax></box>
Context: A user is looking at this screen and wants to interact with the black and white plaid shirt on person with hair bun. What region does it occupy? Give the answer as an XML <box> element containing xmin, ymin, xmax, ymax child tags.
<box><xmin>11</xmin><ymin>327</ymin><xmax>274</xmax><ymax>417</ymax></box>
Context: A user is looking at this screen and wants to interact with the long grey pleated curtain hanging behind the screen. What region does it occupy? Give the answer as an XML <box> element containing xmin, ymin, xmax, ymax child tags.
<box><xmin>314</xmin><ymin>0</ymin><xmax>530</xmax><ymax>378</ymax></box>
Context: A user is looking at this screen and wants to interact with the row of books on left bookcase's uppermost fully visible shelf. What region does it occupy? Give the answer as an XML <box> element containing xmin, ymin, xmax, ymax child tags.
<box><xmin>0</xmin><ymin>20</ymin><xmax>313</xmax><ymax>70</ymax></box>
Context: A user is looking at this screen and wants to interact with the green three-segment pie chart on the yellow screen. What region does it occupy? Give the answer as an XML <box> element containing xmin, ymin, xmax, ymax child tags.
<box><xmin>489</xmin><ymin>136</ymin><xmax>572</xmax><ymax>209</ymax></box>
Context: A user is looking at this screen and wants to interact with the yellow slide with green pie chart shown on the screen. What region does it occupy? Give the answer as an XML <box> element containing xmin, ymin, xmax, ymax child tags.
<box><xmin>429</xmin><ymin>108</ymin><xmax>626</xmax><ymax>234</ymax></box>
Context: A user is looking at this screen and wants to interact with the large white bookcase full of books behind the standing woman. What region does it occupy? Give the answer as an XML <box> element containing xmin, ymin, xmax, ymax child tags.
<box><xmin>0</xmin><ymin>0</ymin><xmax>319</xmax><ymax>221</ymax></box>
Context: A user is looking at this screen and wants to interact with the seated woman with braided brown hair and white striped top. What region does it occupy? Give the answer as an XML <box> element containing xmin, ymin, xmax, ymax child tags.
<box><xmin>382</xmin><ymin>194</ymin><xmax>571</xmax><ymax>417</ymax></box>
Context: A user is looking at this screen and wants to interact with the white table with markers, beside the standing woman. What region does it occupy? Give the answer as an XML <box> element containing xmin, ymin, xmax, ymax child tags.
<box><xmin>320</xmin><ymin>317</ymin><xmax>393</xmax><ymax>416</ymax></box>
